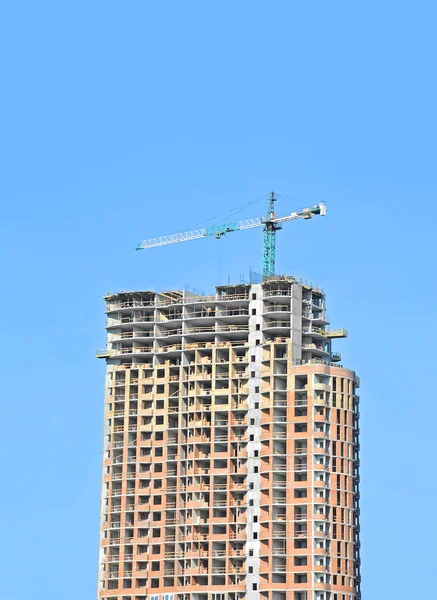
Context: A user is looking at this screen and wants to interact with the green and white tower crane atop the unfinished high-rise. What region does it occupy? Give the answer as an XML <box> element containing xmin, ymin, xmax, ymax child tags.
<box><xmin>136</xmin><ymin>192</ymin><xmax>326</xmax><ymax>279</ymax></box>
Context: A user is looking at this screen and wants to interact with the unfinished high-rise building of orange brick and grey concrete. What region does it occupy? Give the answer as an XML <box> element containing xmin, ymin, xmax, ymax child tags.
<box><xmin>98</xmin><ymin>277</ymin><xmax>360</xmax><ymax>600</ymax></box>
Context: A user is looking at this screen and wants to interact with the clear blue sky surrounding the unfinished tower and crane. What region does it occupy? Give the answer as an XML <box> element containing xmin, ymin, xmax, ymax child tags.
<box><xmin>0</xmin><ymin>0</ymin><xmax>437</xmax><ymax>600</ymax></box>
